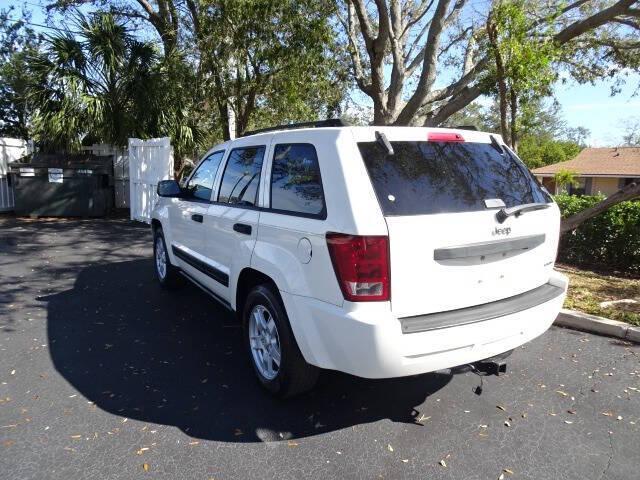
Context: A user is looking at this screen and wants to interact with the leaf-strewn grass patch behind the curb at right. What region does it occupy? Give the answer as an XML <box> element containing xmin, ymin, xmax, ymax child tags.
<box><xmin>556</xmin><ymin>265</ymin><xmax>640</xmax><ymax>326</ymax></box>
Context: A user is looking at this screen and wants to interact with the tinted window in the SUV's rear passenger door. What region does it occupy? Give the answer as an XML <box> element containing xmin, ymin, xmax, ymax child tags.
<box><xmin>218</xmin><ymin>146</ymin><xmax>265</xmax><ymax>206</ymax></box>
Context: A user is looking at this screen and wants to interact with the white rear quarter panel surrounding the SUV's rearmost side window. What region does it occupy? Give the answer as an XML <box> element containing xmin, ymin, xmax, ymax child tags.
<box><xmin>251</xmin><ymin>128</ymin><xmax>387</xmax><ymax>305</ymax></box>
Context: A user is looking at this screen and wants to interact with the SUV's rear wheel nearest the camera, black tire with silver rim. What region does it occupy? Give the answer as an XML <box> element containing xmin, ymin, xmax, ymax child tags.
<box><xmin>242</xmin><ymin>284</ymin><xmax>319</xmax><ymax>398</ymax></box>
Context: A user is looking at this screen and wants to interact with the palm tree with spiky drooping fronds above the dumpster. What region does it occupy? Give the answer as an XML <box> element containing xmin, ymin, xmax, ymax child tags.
<box><xmin>29</xmin><ymin>12</ymin><xmax>197</xmax><ymax>155</ymax></box>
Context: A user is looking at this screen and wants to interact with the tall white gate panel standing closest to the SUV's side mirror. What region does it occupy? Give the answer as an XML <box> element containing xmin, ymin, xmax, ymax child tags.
<box><xmin>129</xmin><ymin>137</ymin><xmax>173</xmax><ymax>223</ymax></box>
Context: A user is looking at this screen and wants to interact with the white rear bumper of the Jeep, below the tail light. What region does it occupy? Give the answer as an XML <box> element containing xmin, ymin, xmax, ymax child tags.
<box><xmin>282</xmin><ymin>272</ymin><xmax>568</xmax><ymax>378</ymax></box>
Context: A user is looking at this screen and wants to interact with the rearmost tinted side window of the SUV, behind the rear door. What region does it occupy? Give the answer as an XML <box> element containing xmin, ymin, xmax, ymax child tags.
<box><xmin>271</xmin><ymin>143</ymin><xmax>325</xmax><ymax>217</ymax></box>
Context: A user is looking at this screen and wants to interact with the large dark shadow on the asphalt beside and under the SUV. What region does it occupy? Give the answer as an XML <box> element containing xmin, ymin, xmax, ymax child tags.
<box><xmin>39</xmin><ymin>260</ymin><xmax>451</xmax><ymax>442</ymax></box>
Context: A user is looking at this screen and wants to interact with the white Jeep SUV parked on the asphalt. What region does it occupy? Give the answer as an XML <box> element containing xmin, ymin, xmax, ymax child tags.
<box><xmin>152</xmin><ymin>121</ymin><xmax>567</xmax><ymax>396</ymax></box>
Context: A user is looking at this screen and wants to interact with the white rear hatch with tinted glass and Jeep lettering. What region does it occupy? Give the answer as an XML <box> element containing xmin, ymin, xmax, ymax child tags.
<box><xmin>355</xmin><ymin>128</ymin><xmax>560</xmax><ymax>317</ymax></box>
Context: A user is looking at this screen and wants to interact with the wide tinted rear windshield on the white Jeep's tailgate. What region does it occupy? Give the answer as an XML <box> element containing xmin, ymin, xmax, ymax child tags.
<box><xmin>358</xmin><ymin>142</ymin><xmax>552</xmax><ymax>215</ymax></box>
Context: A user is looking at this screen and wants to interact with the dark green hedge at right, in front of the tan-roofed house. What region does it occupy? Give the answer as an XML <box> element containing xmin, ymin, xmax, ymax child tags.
<box><xmin>555</xmin><ymin>195</ymin><xmax>640</xmax><ymax>274</ymax></box>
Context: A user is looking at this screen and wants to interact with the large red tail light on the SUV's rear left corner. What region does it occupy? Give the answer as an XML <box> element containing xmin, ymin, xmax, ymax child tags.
<box><xmin>327</xmin><ymin>233</ymin><xmax>391</xmax><ymax>302</ymax></box>
